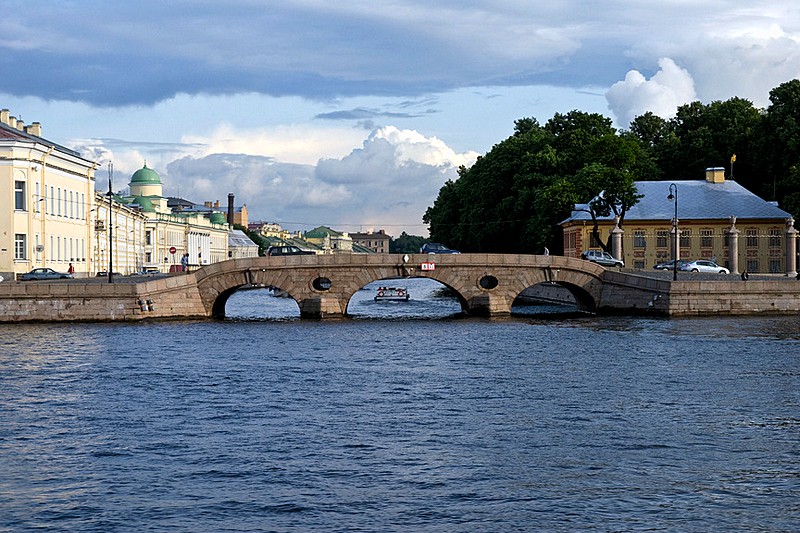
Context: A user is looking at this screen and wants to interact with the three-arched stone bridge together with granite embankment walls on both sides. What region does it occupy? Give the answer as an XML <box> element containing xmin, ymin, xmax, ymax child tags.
<box><xmin>0</xmin><ymin>254</ymin><xmax>800</xmax><ymax>322</ymax></box>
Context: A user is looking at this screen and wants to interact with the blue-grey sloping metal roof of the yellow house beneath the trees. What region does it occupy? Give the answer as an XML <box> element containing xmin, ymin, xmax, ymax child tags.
<box><xmin>562</xmin><ymin>180</ymin><xmax>791</xmax><ymax>224</ymax></box>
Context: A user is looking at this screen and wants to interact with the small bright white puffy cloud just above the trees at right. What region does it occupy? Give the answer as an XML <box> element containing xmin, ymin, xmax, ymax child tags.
<box><xmin>606</xmin><ymin>58</ymin><xmax>697</xmax><ymax>127</ymax></box>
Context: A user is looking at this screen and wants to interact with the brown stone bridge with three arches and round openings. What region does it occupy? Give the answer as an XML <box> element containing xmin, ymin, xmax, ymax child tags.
<box><xmin>191</xmin><ymin>254</ymin><xmax>669</xmax><ymax>318</ymax></box>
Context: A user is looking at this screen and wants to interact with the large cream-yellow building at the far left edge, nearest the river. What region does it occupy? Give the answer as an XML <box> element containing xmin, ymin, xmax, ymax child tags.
<box><xmin>0</xmin><ymin>109</ymin><xmax>97</xmax><ymax>279</ymax></box>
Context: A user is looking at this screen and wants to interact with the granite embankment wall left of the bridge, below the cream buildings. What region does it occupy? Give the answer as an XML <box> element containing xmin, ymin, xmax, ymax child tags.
<box><xmin>0</xmin><ymin>274</ymin><xmax>208</xmax><ymax>322</ymax></box>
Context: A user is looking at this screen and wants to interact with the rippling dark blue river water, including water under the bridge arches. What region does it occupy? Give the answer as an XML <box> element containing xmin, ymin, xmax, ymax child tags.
<box><xmin>0</xmin><ymin>280</ymin><xmax>800</xmax><ymax>532</ymax></box>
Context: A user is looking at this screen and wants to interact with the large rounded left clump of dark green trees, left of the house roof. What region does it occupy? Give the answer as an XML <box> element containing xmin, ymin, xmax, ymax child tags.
<box><xmin>423</xmin><ymin>111</ymin><xmax>652</xmax><ymax>253</ymax></box>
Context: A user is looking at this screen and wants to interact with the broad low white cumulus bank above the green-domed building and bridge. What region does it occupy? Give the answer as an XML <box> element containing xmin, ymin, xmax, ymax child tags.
<box><xmin>150</xmin><ymin>126</ymin><xmax>478</xmax><ymax>235</ymax></box>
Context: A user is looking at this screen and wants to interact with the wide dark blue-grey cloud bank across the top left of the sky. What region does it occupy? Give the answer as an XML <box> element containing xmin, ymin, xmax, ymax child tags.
<box><xmin>0</xmin><ymin>0</ymin><xmax>632</xmax><ymax>106</ymax></box>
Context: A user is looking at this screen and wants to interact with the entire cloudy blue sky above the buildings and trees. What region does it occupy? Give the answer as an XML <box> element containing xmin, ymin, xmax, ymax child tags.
<box><xmin>0</xmin><ymin>0</ymin><xmax>800</xmax><ymax>236</ymax></box>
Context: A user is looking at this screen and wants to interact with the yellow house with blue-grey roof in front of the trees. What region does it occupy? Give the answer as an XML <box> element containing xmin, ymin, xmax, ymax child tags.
<box><xmin>561</xmin><ymin>168</ymin><xmax>796</xmax><ymax>273</ymax></box>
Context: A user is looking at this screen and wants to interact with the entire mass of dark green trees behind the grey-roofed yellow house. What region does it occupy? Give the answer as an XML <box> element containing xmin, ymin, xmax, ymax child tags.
<box><xmin>423</xmin><ymin>80</ymin><xmax>800</xmax><ymax>253</ymax></box>
